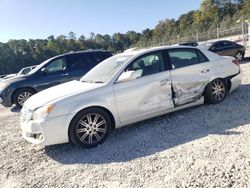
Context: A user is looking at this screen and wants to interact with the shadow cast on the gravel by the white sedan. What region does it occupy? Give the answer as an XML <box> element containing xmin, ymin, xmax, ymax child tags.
<box><xmin>45</xmin><ymin>85</ymin><xmax>250</xmax><ymax>164</ymax></box>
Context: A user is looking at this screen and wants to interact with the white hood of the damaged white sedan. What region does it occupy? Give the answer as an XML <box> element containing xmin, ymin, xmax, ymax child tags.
<box><xmin>24</xmin><ymin>80</ymin><xmax>103</xmax><ymax>110</ymax></box>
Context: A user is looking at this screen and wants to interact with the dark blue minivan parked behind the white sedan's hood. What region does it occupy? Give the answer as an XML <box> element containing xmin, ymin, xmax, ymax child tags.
<box><xmin>0</xmin><ymin>50</ymin><xmax>112</xmax><ymax>107</ymax></box>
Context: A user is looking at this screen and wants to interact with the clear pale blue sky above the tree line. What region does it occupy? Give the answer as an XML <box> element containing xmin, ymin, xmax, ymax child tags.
<box><xmin>0</xmin><ymin>0</ymin><xmax>202</xmax><ymax>42</ymax></box>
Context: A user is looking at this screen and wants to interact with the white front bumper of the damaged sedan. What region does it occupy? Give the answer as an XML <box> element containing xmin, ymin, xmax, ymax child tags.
<box><xmin>20</xmin><ymin>114</ymin><xmax>74</xmax><ymax>146</ymax></box>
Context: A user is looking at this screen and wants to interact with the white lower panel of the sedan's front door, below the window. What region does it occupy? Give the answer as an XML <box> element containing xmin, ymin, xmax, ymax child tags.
<box><xmin>114</xmin><ymin>71</ymin><xmax>174</xmax><ymax>123</ymax></box>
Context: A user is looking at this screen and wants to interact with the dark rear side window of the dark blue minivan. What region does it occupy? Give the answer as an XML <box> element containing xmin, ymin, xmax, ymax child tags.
<box><xmin>68</xmin><ymin>54</ymin><xmax>96</xmax><ymax>71</ymax></box>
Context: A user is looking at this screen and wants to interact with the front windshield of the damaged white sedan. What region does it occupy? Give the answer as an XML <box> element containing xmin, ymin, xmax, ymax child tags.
<box><xmin>81</xmin><ymin>55</ymin><xmax>132</xmax><ymax>83</ymax></box>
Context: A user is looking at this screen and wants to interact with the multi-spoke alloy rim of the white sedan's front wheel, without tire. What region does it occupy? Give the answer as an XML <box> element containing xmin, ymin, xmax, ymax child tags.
<box><xmin>76</xmin><ymin>113</ymin><xmax>107</xmax><ymax>145</ymax></box>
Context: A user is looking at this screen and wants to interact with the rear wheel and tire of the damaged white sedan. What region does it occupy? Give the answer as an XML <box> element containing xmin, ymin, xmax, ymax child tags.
<box><xmin>204</xmin><ymin>79</ymin><xmax>228</xmax><ymax>104</ymax></box>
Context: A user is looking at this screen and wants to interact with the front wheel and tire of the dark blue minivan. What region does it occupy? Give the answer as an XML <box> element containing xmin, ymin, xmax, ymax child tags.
<box><xmin>13</xmin><ymin>88</ymin><xmax>36</xmax><ymax>108</ymax></box>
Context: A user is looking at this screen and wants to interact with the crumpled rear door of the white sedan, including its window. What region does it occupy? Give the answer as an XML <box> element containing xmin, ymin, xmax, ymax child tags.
<box><xmin>167</xmin><ymin>48</ymin><xmax>214</xmax><ymax>106</ymax></box>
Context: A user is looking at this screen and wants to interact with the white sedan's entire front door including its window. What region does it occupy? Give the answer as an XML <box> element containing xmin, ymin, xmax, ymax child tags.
<box><xmin>114</xmin><ymin>52</ymin><xmax>174</xmax><ymax>122</ymax></box>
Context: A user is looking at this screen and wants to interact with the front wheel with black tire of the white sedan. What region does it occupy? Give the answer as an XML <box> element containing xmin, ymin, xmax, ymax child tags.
<box><xmin>68</xmin><ymin>107</ymin><xmax>111</xmax><ymax>148</ymax></box>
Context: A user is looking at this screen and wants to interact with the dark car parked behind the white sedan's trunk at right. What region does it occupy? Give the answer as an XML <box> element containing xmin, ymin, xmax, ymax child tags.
<box><xmin>208</xmin><ymin>40</ymin><xmax>246</xmax><ymax>61</ymax></box>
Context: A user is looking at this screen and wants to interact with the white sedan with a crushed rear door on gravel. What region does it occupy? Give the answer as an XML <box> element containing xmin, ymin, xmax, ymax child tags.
<box><xmin>20</xmin><ymin>46</ymin><xmax>241</xmax><ymax>148</ymax></box>
